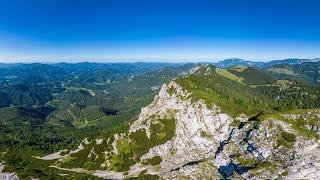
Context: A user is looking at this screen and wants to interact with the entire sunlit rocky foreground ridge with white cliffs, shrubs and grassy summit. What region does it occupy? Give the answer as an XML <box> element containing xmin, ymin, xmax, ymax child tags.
<box><xmin>21</xmin><ymin>65</ymin><xmax>320</xmax><ymax>179</ymax></box>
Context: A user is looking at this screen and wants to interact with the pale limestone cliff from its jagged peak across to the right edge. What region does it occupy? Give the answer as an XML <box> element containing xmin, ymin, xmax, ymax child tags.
<box><xmin>125</xmin><ymin>78</ymin><xmax>320</xmax><ymax>179</ymax></box>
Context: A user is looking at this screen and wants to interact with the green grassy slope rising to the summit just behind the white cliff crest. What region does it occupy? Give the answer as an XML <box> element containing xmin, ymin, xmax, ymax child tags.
<box><xmin>176</xmin><ymin>66</ymin><xmax>274</xmax><ymax>115</ymax></box>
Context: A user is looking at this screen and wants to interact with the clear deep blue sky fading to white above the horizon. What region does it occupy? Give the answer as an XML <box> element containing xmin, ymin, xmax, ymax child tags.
<box><xmin>0</xmin><ymin>0</ymin><xmax>320</xmax><ymax>62</ymax></box>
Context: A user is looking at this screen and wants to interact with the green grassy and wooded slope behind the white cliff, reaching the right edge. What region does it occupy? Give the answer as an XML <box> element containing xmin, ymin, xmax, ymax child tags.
<box><xmin>175</xmin><ymin>66</ymin><xmax>320</xmax><ymax>115</ymax></box>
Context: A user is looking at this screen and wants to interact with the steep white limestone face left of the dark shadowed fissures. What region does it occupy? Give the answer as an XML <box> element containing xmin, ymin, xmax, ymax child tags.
<box><xmin>130</xmin><ymin>81</ymin><xmax>232</xmax><ymax>172</ymax></box>
